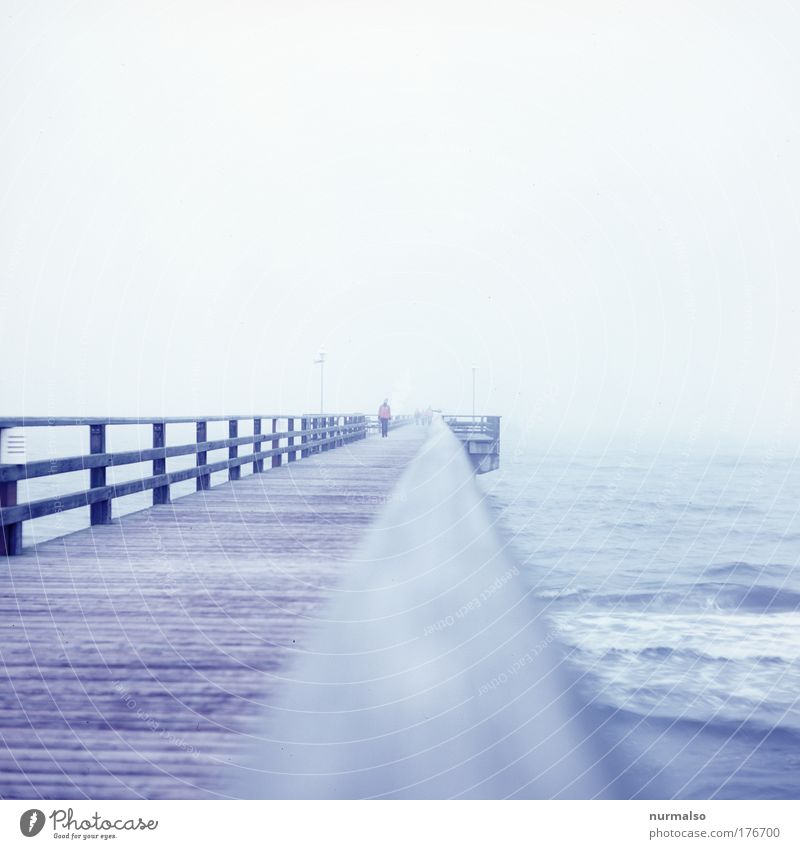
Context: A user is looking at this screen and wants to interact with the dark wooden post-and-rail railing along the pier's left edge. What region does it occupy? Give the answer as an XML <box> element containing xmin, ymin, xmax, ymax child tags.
<box><xmin>0</xmin><ymin>414</ymin><xmax>368</xmax><ymax>555</ymax></box>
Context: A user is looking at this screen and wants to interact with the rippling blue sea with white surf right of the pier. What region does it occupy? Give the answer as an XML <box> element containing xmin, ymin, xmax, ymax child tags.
<box><xmin>478</xmin><ymin>443</ymin><xmax>800</xmax><ymax>798</ymax></box>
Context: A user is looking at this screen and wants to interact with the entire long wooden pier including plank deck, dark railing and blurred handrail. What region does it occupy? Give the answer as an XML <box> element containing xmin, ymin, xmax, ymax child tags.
<box><xmin>0</xmin><ymin>416</ymin><xmax>653</xmax><ymax>799</ymax></box>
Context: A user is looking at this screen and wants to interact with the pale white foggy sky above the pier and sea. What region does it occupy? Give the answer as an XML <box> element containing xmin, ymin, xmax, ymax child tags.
<box><xmin>0</xmin><ymin>0</ymin><xmax>800</xmax><ymax>446</ymax></box>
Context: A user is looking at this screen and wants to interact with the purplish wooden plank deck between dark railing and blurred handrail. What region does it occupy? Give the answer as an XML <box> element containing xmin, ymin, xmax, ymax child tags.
<box><xmin>0</xmin><ymin>427</ymin><xmax>425</xmax><ymax>799</ymax></box>
